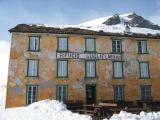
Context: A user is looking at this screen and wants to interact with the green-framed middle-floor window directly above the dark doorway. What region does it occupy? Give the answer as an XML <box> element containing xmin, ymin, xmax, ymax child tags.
<box><xmin>85</xmin><ymin>61</ymin><xmax>96</xmax><ymax>78</ymax></box>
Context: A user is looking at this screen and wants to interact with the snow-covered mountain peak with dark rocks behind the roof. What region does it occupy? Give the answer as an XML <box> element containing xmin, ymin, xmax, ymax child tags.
<box><xmin>80</xmin><ymin>13</ymin><xmax>160</xmax><ymax>30</ymax></box>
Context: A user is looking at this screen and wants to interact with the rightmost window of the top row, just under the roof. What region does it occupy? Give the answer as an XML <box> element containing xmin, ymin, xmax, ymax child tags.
<box><xmin>138</xmin><ymin>41</ymin><xmax>148</xmax><ymax>54</ymax></box>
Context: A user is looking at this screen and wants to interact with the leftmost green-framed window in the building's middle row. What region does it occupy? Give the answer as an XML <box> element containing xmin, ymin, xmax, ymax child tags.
<box><xmin>27</xmin><ymin>59</ymin><xmax>39</xmax><ymax>77</ymax></box>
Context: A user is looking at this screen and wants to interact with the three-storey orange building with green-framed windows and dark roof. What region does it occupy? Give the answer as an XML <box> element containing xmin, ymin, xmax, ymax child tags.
<box><xmin>6</xmin><ymin>24</ymin><xmax>160</xmax><ymax>108</ymax></box>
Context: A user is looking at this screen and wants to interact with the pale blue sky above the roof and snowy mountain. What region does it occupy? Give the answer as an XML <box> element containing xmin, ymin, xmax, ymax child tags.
<box><xmin>0</xmin><ymin>0</ymin><xmax>160</xmax><ymax>41</ymax></box>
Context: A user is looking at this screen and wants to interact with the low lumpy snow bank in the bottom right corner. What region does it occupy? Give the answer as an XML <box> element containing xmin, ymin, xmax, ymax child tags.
<box><xmin>104</xmin><ymin>111</ymin><xmax>160</xmax><ymax>120</ymax></box>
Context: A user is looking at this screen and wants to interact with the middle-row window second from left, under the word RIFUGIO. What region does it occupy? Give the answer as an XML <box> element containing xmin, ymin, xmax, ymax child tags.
<box><xmin>57</xmin><ymin>60</ymin><xmax>68</xmax><ymax>77</ymax></box>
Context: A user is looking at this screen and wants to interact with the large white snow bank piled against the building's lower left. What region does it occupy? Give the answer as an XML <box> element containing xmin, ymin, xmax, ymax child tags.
<box><xmin>0</xmin><ymin>100</ymin><xmax>91</xmax><ymax>120</ymax></box>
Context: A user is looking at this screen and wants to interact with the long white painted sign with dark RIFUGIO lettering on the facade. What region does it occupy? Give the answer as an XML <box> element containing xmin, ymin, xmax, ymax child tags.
<box><xmin>56</xmin><ymin>52</ymin><xmax>122</xmax><ymax>60</ymax></box>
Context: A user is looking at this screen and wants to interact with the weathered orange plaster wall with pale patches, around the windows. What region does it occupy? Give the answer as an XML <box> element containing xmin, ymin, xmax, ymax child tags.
<box><xmin>6</xmin><ymin>33</ymin><xmax>160</xmax><ymax>107</ymax></box>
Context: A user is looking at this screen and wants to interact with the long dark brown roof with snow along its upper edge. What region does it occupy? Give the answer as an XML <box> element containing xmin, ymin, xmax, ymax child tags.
<box><xmin>9</xmin><ymin>24</ymin><xmax>160</xmax><ymax>39</ymax></box>
